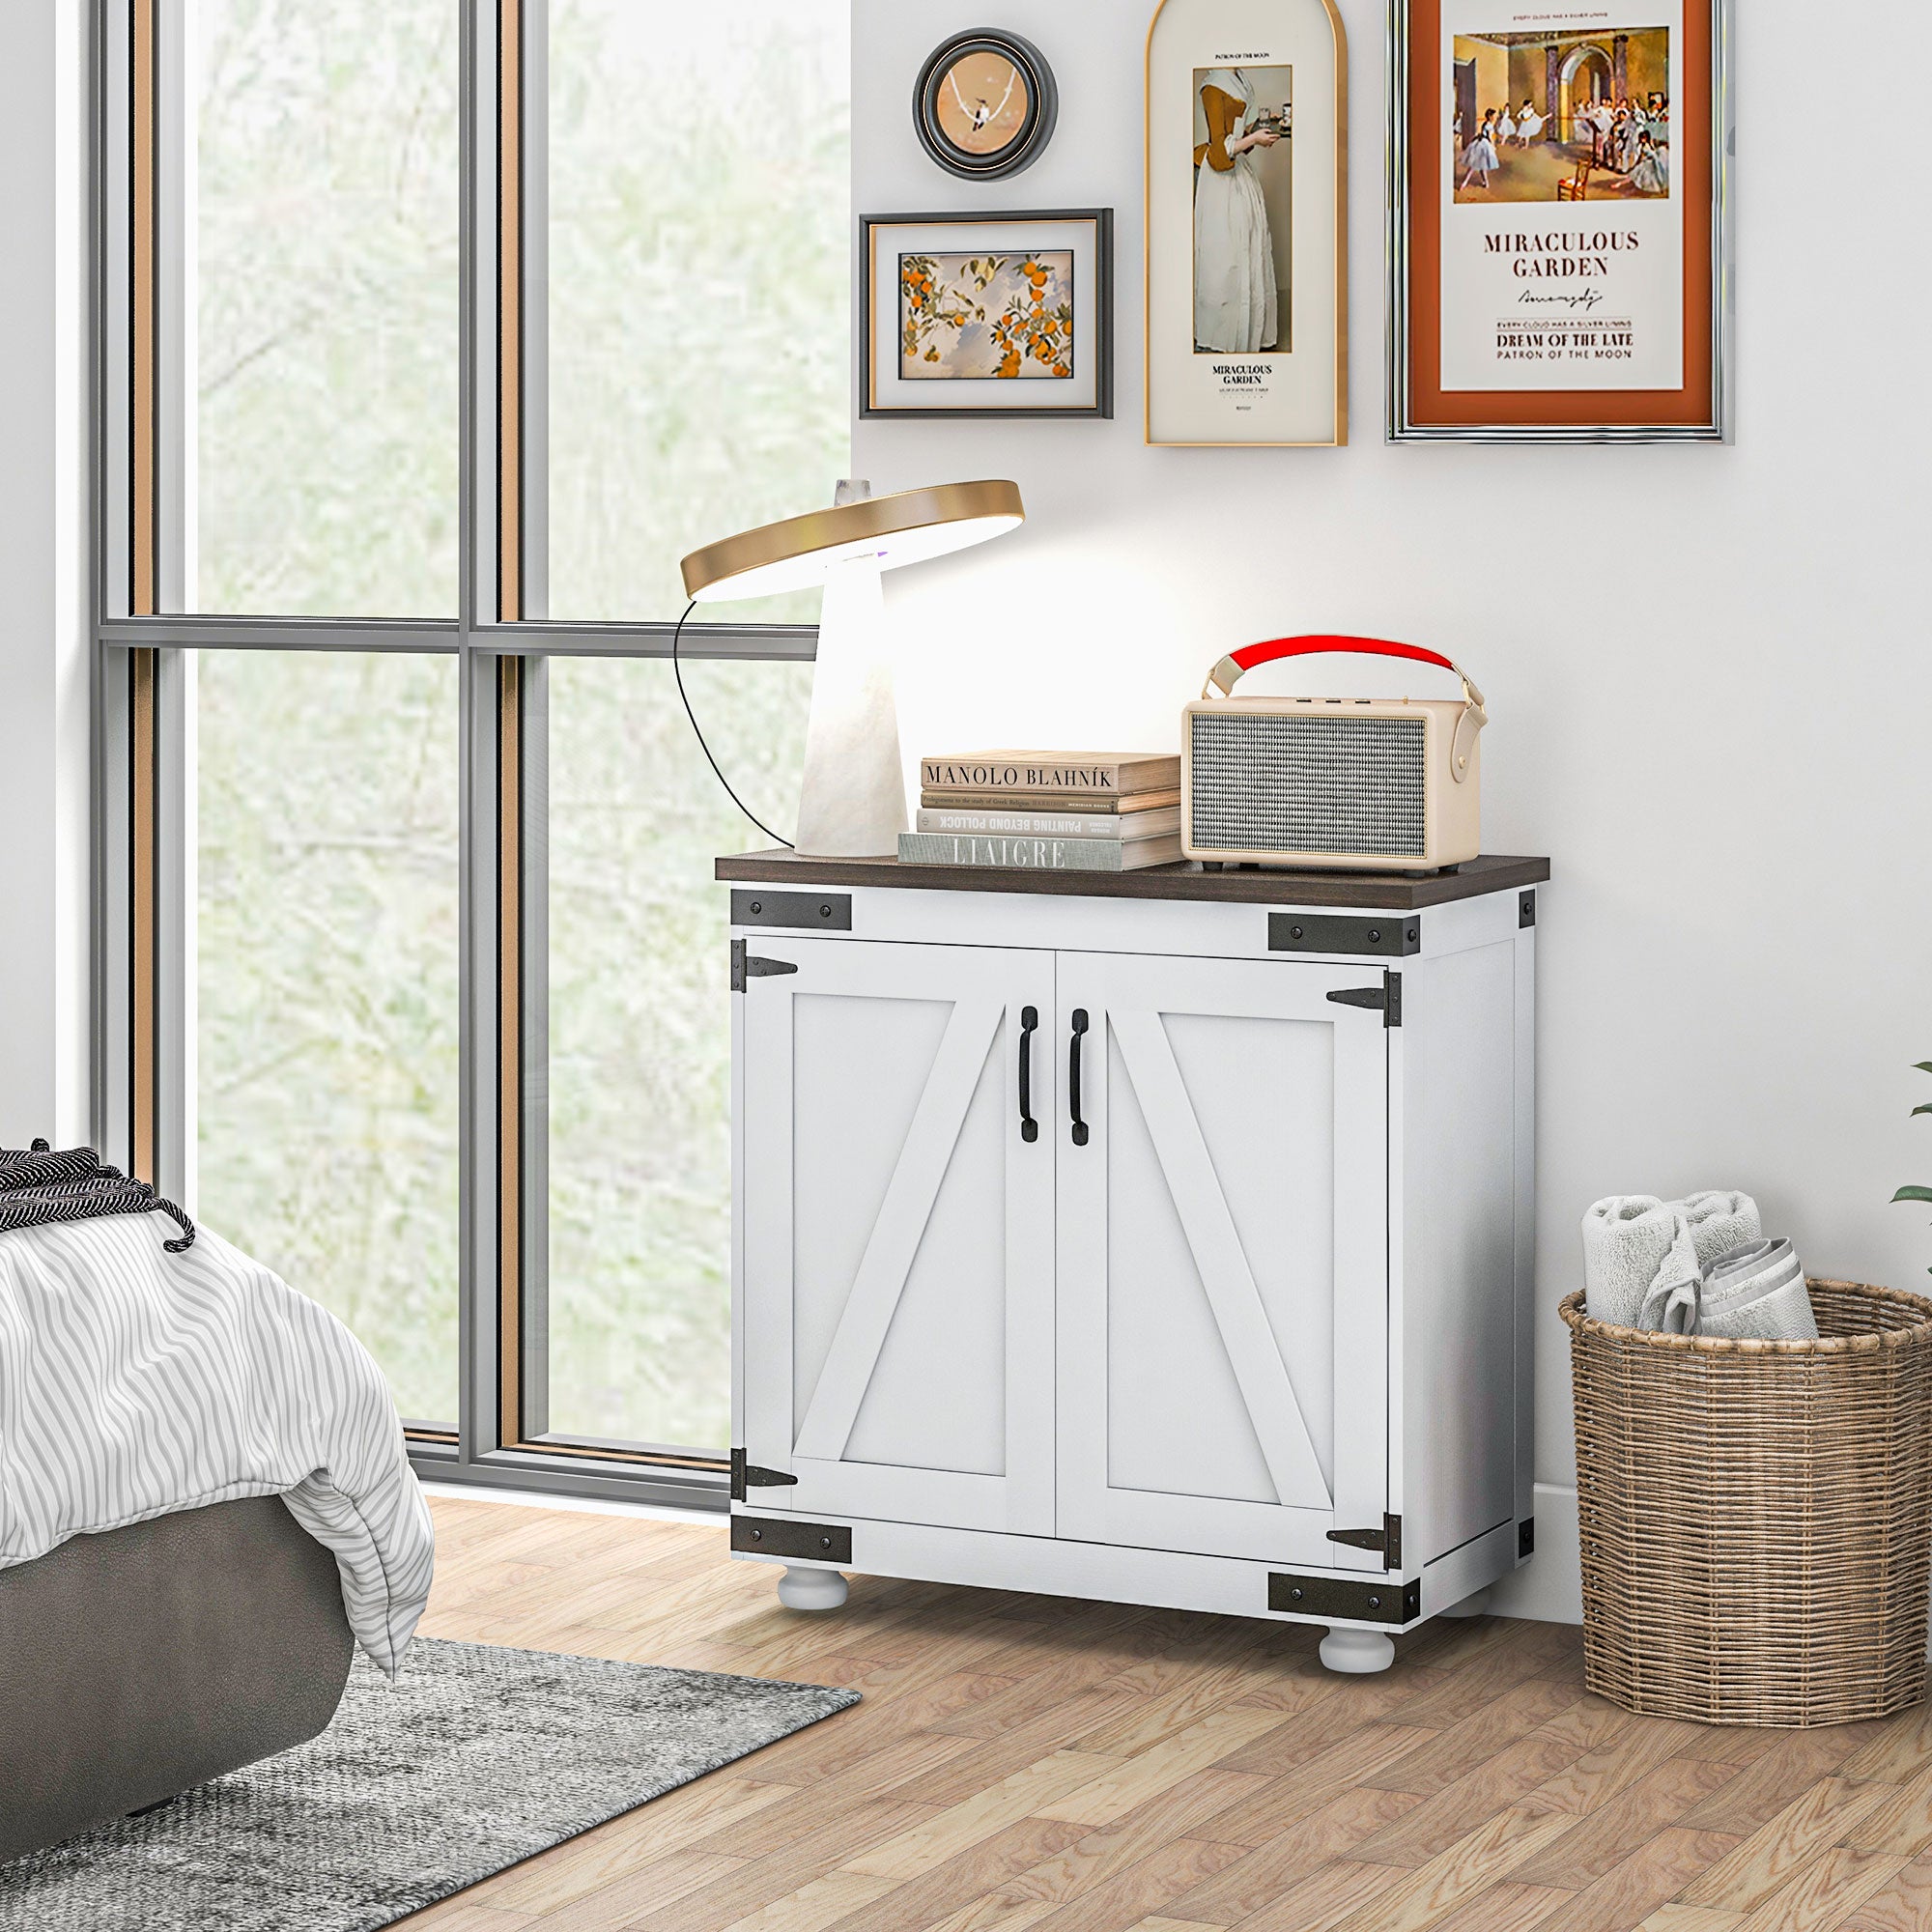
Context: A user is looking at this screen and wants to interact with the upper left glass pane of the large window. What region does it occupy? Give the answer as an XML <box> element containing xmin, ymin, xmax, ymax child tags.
<box><xmin>187</xmin><ymin>0</ymin><xmax>458</xmax><ymax>616</ymax></box>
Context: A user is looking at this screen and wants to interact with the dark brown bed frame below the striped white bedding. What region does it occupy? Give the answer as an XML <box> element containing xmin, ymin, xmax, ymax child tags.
<box><xmin>0</xmin><ymin>1495</ymin><xmax>354</xmax><ymax>1859</ymax></box>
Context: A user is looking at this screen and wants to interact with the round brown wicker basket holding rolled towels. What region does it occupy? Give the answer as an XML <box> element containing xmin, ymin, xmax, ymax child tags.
<box><xmin>1561</xmin><ymin>1281</ymin><xmax>1932</xmax><ymax>1727</ymax></box>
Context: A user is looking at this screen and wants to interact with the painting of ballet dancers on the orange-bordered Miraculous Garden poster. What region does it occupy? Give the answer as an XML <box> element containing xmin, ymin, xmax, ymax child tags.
<box><xmin>1449</xmin><ymin>27</ymin><xmax>1671</xmax><ymax>205</ymax></box>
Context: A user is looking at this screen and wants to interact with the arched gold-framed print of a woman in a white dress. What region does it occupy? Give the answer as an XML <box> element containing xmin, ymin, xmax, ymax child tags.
<box><xmin>1148</xmin><ymin>0</ymin><xmax>1349</xmax><ymax>446</ymax></box>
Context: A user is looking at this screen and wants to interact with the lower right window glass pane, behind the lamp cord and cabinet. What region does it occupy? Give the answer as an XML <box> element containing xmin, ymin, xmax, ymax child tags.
<box><xmin>547</xmin><ymin>659</ymin><xmax>811</xmax><ymax>1451</ymax></box>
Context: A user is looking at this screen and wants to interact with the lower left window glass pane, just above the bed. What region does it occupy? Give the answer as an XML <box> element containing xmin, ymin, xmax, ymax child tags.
<box><xmin>185</xmin><ymin>651</ymin><xmax>458</xmax><ymax>1424</ymax></box>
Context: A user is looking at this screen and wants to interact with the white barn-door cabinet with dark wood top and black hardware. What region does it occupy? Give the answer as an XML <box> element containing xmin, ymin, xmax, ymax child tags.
<box><xmin>719</xmin><ymin>856</ymin><xmax>1549</xmax><ymax>1669</ymax></box>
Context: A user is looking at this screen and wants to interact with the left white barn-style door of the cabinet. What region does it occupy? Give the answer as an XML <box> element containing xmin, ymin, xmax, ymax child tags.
<box><xmin>738</xmin><ymin>933</ymin><xmax>1055</xmax><ymax>1536</ymax></box>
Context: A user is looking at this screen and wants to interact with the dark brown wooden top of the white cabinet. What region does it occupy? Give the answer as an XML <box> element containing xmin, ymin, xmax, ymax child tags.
<box><xmin>717</xmin><ymin>852</ymin><xmax>1549</xmax><ymax>912</ymax></box>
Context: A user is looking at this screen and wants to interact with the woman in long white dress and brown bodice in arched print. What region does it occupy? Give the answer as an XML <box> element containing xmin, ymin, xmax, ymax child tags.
<box><xmin>1194</xmin><ymin>68</ymin><xmax>1281</xmax><ymax>355</ymax></box>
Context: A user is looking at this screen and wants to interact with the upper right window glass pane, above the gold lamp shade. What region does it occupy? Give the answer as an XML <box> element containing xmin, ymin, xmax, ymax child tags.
<box><xmin>547</xmin><ymin>0</ymin><xmax>852</xmax><ymax>622</ymax></box>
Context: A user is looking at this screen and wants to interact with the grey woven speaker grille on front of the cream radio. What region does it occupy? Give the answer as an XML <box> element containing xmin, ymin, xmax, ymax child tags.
<box><xmin>1192</xmin><ymin>709</ymin><xmax>1428</xmax><ymax>858</ymax></box>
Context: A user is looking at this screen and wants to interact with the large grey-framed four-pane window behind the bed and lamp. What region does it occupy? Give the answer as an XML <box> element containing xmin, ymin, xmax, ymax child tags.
<box><xmin>97</xmin><ymin>0</ymin><xmax>850</xmax><ymax>1495</ymax></box>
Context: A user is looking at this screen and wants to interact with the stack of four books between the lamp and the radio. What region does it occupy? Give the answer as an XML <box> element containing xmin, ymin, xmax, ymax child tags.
<box><xmin>898</xmin><ymin>752</ymin><xmax>1180</xmax><ymax>871</ymax></box>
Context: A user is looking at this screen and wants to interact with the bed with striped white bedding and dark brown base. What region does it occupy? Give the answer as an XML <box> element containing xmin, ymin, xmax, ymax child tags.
<box><xmin>0</xmin><ymin>1215</ymin><xmax>435</xmax><ymax>1859</ymax></box>
